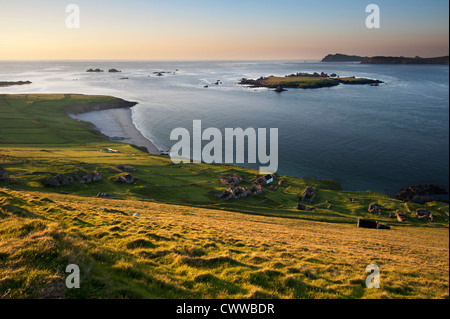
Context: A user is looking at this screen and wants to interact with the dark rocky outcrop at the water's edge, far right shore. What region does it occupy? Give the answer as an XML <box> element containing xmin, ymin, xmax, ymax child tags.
<box><xmin>395</xmin><ymin>184</ymin><xmax>448</xmax><ymax>205</ymax></box>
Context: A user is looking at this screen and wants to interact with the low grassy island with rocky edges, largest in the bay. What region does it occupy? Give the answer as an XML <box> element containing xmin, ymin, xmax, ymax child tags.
<box><xmin>238</xmin><ymin>72</ymin><xmax>384</xmax><ymax>91</ymax></box>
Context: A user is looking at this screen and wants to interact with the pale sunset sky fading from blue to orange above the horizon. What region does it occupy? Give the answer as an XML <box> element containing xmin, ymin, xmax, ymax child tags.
<box><xmin>0</xmin><ymin>0</ymin><xmax>449</xmax><ymax>60</ymax></box>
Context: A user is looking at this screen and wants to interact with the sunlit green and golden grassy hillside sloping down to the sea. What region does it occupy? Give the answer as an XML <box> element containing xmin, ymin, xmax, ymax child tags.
<box><xmin>0</xmin><ymin>95</ymin><xmax>449</xmax><ymax>298</ymax></box>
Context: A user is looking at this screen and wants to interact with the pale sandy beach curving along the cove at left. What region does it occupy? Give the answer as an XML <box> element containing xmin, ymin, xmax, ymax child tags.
<box><xmin>70</xmin><ymin>108</ymin><xmax>161</xmax><ymax>155</ymax></box>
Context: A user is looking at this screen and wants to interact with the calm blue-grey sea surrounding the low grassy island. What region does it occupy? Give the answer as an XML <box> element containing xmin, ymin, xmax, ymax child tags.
<box><xmin>0</xmin><ymin>61</ymin><xmax>449</xmax><ymax>194</ymax></box>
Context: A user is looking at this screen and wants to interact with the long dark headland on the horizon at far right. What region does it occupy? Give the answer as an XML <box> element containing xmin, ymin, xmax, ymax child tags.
<box><xmin>322</xmin><ymin>53</ymin><xmax>449</xmax><ymax>65</ymax></box>
